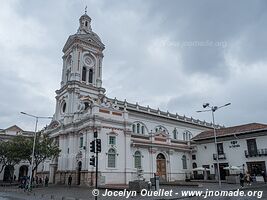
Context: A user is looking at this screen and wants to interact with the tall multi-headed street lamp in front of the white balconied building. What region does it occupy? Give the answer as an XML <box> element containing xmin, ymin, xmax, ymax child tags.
<box><xmin>197</xmin><ymin>103</ymin><xmax>231</xmax><ymax>188</ymax></box>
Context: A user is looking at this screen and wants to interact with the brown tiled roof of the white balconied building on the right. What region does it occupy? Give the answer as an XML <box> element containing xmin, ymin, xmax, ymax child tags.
<box><xmin>192</xmin><ymin>123</ymin><xmax>267</xmax><ymax>141</ymax></box>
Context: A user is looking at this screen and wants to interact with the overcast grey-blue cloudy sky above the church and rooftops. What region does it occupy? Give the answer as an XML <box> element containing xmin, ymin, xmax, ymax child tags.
<box><xmin>0</xmin><ymin>0</ymin><xmax>267</xmax><ymax>130</ymax></box>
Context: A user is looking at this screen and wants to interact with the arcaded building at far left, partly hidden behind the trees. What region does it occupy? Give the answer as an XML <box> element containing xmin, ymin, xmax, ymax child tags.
<box><xmin>0</xmin><ymin>125</ymin><xmax>33</xmax><ymax>182</ymax></box>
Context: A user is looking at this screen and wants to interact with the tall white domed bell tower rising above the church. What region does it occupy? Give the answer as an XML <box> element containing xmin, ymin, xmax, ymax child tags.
<box><xmin>55</xmin><ymin>11</ymin><xmax>105</xmax><ymax>123</ymax></box>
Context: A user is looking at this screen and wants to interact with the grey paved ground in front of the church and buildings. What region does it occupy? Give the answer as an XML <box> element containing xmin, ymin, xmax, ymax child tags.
<box><xmin>0</xmin><ymin>183</ymin><xmax>267</xmax><ymax>200</ymax></box>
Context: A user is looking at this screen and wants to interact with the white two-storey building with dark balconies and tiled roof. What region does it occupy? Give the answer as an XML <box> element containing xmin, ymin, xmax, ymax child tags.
<box><xmin>192</xmin><ymin>123</ymin><xmax>267</xmax><ymax>180</ymax></box>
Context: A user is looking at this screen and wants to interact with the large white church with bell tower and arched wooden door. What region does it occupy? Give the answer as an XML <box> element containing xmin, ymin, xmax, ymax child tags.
<box><xmin>43</xmin><ymin>13</ymin><xmax>212</xmax><ymax>185</ymax></box>
